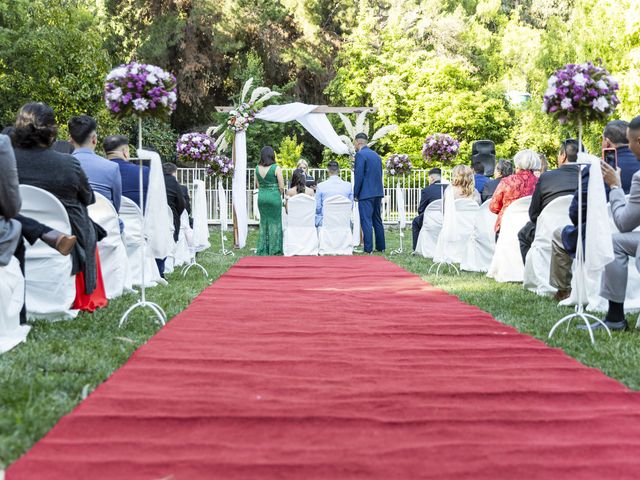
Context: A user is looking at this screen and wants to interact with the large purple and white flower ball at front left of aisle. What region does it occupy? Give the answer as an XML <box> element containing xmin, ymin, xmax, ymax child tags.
<box><xmin>104</xmin><ymin>62</ymin><xmax>177</xmax><ymax>118</ymax></box>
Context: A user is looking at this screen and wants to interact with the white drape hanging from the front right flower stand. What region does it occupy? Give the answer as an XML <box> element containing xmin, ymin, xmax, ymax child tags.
<box><xmin>578</xmin><ymin>153</ymin><xmax>614</xmax><ymax>275</ymax></box>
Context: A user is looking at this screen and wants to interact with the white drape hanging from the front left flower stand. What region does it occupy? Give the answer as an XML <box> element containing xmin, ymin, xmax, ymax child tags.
<box><xmin>138</xmin><ymin>149</ymin><xmax>173</xmax><ymax>258</ymax></box>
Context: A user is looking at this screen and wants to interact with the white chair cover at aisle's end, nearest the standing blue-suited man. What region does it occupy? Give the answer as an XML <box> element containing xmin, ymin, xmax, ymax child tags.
<box><xmin>318</xmin><ymin>195</ymin><xmax>353</xmax><ymax>255</ymax></box>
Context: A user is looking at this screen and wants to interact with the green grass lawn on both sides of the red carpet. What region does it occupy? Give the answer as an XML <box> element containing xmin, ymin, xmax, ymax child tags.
<box><xmin>0</xmin><ymin>230</ymin><xmax>640</xmax><ymax>467</ymax></box>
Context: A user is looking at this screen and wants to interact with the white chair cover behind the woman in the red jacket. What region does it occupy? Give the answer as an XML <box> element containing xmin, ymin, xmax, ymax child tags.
<box><xmin>487</xmin><ymin>196</ymin><xmax>531</xmax><ymax>282</ymax></box>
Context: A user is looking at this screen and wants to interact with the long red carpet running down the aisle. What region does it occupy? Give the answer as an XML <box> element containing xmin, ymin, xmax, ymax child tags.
<box><xmin>7</xmin><ymin>257</ymin><xmax>640</xmax><ymax>480</ymax></box>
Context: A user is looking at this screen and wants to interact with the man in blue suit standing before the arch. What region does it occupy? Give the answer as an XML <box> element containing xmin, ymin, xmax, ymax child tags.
<box><xmin>353</xmin><ymin>133</ymin><xmax>386</xmax><ymax>253</ymax></box>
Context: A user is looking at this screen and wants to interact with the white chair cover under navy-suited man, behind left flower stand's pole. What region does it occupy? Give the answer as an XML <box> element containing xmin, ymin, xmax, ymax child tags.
<box><xmin>120</xmin><ymin>197</ymin><xmax>162</xmax><ymax>287</ymax></box>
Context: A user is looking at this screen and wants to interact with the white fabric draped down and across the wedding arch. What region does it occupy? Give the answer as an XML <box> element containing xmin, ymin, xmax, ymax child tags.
<box><xmin>232</xmin><ymin>102</ymin><xmax>349</xmax><ymax>248</ymax></box>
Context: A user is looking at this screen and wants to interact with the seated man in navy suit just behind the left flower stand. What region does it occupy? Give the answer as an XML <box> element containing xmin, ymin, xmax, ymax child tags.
<box><xmin>102</xmin><ymin>135</ymin><xmax>149</xmax><ymax>210</ymax></box>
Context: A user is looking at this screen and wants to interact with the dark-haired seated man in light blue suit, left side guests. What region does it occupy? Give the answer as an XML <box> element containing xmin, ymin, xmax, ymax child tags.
<box><xmin>67</xmin><ymin>115</ymin><xmax>122</xmax><ymax>212</ymax></box>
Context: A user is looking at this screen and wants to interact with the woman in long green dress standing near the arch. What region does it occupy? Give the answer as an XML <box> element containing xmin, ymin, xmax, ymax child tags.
<box><xmin>256</xmin><ymin>147</ymin><xmax>284</xmax><ymax>255</ymax></box>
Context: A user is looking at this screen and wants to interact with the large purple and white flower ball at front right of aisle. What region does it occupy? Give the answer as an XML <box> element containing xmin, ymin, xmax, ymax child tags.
<box><xmin>542</xmin><ymin>62</ymin><xmax>620</xmax><ymax>124</ymax></box>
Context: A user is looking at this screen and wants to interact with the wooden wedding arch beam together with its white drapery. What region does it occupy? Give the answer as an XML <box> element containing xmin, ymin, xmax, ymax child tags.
<box><xmin>215</xmin><ymin>102</ymin><xmax>376</xmax><ymax>248</ymax></box>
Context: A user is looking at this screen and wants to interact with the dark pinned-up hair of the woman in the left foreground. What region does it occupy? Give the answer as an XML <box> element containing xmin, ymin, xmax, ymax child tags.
<box><xmin>13</xmin><ymin>102</ymin><xmax>58</xmax><ymax>148</ymax></box>
